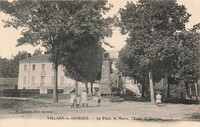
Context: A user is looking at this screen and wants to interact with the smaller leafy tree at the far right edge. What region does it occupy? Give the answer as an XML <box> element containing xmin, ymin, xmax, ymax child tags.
<box><xmin>177</xmin><ymin>30</ymin><xmax>200</xmax><ymax>100</ymax></box>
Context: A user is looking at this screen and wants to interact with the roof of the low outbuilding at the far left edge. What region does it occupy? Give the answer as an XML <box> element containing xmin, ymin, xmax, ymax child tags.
<box><xmin>0</xmin><ymin>77</ymin><xmax>18</xmax><ymax>85</ymax></box>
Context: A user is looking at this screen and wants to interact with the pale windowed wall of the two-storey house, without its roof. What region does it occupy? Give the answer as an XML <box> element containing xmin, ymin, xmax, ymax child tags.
<box><xmin>18</xmin><ymin>63</ymin><xmax>74</xmax><ymax>89</ymax></box>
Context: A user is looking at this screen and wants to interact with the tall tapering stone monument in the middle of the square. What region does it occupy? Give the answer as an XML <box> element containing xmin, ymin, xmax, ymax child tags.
<box><xmin>99</xmin><ymin>52</ymin><xmax>112</xmax><ymax>95</ymax></box>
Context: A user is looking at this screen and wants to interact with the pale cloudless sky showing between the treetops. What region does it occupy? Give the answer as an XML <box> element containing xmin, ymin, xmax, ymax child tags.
<box><xmin>0</xmin><ymin>0</ymin><xmax>200</xmax><ymax>59</ymax></box>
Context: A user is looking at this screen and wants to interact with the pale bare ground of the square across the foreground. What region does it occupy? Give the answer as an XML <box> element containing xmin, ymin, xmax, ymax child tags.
<box><xmin>0</xmin><ymin>95</ymin><xmax>200</xmax><ymax>121</ymax></box>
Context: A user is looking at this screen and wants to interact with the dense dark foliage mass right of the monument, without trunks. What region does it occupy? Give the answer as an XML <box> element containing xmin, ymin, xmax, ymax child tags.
<box><xmin>119</xmin><ymin>0</ymin><xmax>197</xmax><ymax>98</ymax></box>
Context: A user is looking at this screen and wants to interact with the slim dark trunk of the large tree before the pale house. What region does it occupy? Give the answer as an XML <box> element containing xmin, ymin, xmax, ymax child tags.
<box><xmin>53</xmin><ymin>64</ymin><xmax>58</xmax><ymax>103</ymax></box>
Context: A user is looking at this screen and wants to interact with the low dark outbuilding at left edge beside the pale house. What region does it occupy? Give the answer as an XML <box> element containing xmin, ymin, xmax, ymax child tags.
<box><xmin>0</xmin><ymin>77</ymin><xmax>18</xmax><ymax>90</ymax></box>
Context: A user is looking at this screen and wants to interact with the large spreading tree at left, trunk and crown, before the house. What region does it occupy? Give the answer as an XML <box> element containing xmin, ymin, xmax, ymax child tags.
<box><xmin>0</xmin><ymin>0</ymin><xmax>112</xmax><ymax>103</ymax></box>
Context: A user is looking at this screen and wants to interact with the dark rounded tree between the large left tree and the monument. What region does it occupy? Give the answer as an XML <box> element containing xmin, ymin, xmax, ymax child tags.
<box><xmin>63</xmin><ymin>44</ymin><xmax>105</xmax><ymax>93</ymax></box>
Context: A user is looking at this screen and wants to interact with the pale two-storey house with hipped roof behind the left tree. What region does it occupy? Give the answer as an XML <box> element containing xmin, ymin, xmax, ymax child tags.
<box><xmin>18</xmin><ymin>54</ymin><xmax>84</xmax><ymax>94</ymax></box>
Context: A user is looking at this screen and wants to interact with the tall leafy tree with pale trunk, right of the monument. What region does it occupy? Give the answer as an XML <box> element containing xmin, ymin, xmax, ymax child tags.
<box><xmin>119</xmin><ymin>0</ymin><xmax>190</xmax><ymax>103</ymax></box>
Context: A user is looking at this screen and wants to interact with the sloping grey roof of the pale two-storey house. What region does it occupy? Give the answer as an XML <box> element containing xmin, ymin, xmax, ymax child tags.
<box><xmin>20</xmin><ymin>54</ymin><xmax>51</xmax><ymax>63</ymax></box>
